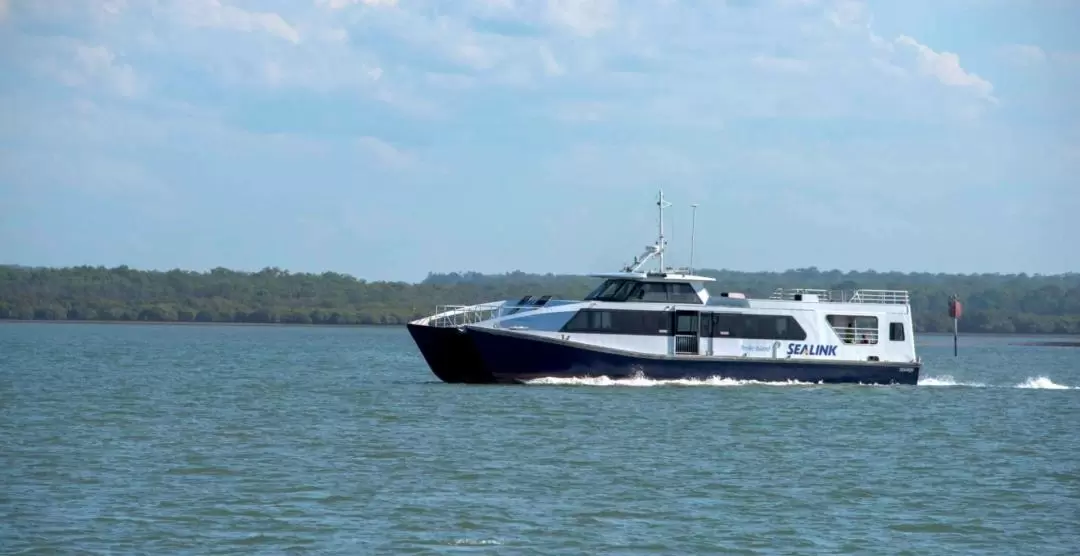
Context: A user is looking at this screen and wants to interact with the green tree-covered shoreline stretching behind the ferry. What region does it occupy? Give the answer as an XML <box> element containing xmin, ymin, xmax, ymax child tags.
<box><xmin>0</xmin><ymin>266</ymin><xmax>1080</xmax><ymax>335</ymax></box>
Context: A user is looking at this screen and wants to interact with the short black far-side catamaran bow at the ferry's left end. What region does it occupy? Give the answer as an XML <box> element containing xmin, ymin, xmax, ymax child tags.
<box><xmin>406</xmin><ymin>324</ymin><xmax>496</xmax><ymax>384</ymax></box>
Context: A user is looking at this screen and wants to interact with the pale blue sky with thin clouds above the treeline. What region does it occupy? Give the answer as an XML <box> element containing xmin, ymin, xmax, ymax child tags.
<box><xmin>0</xmin><ymin>0</ymin><xmax>1080</xmax><ymax>281</ymax></box>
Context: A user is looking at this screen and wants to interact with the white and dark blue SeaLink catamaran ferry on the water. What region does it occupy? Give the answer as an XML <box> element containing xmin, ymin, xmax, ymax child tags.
<box><xmin>407</xmin><ymin>191</ymin><xmax>921</xmax><ymax>384</ymax></box>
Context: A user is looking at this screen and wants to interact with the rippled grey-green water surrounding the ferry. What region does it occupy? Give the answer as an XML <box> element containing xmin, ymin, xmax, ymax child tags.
<box><xmin>0</xmin><ymin>324</ymin><xmax>1080</xmax><ymax>555</ymax></box>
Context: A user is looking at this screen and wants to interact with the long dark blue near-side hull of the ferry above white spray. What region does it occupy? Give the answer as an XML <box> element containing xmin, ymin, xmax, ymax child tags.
<box><xmin>467</xmin><ymin>328</ymin><xmax>919</xmax><ymax>384</ymax></box>
